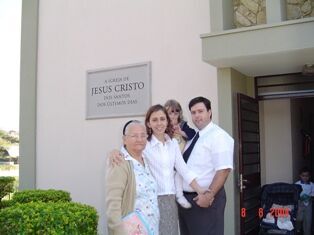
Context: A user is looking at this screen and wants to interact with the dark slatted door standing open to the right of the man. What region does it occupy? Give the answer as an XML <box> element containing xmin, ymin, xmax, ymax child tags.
<box><xmin>237</xmin><ymin>94</ymin><xmax>261</xmax><ymax>235</ymax></box>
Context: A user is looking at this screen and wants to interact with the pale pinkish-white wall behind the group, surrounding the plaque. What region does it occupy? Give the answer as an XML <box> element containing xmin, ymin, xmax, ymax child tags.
<box><xmin>21</xmin><ymin>0</ymin><xmax>218</xmax><ymax>234</ymax></box>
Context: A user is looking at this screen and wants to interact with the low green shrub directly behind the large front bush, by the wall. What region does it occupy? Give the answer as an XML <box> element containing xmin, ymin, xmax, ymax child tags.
<box><xmin>12</xmin><ymin>189</ymin><xmax>71</xmax><ymax>203</ymax></box>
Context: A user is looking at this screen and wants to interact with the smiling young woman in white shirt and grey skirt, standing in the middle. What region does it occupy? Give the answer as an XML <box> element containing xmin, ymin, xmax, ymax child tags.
<box><xmin>144</xmin><ymin>104</ymin><xmax>202</xmax><ymax>235</ymax></box>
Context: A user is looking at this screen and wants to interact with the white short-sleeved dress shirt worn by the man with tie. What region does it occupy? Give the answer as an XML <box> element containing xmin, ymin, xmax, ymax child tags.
<box><xmin>183</xmin><ymin>122</ymin><xmax>234</xmax><ymax>192</ymax></box>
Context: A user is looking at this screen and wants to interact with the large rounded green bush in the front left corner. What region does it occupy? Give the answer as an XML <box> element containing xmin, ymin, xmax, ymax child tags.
<box><xmin>0</xmin><ymin>202</ymin><xmax>98</xmax><ymax>235</ymax></box>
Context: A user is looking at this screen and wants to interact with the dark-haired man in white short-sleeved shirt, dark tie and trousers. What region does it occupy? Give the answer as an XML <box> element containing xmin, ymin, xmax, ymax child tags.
<box><xmin>179</xmin><ymin>97</ymin><xmax>234</xmax><ymax>235</ymax></box>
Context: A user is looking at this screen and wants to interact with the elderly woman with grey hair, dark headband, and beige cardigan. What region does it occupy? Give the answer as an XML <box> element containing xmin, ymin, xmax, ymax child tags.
<box><xmin>106</xmin><ymin>120</ymin><xmax>159</xmax><ymax>235</ymax></box>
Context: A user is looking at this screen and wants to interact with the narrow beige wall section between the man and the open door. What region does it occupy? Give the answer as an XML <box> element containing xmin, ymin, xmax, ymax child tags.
<box><xmin>218</xmin><ymin>68</ymin><xmax>254</xmax><ymax>235</ymax></box>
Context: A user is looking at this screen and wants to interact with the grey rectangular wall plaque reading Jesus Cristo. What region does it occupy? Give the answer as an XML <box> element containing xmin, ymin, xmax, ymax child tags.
<box><xmin>86</xmin><ymin>62</ymin><xmax>151</xmax><ymax>119</ymax></box>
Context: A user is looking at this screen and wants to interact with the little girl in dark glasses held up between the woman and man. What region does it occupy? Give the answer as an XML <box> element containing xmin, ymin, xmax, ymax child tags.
<box><xmin>164</xmin><ymin>100</ymin><xmax>196</xmax><ymax>208</ymax></box>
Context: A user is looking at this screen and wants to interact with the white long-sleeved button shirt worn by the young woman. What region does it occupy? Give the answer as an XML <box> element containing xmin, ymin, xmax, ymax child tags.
<box><xmin>144</xmin><ymin>135</ymin><xmax>196</xmax><ymax>195</ymax></box>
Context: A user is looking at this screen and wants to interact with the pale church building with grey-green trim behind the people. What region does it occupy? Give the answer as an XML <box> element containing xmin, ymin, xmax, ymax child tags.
<box><xmin>20</xmin><ymin>0</ymin><xmax>314</xmax><ymax>235</ymax></box>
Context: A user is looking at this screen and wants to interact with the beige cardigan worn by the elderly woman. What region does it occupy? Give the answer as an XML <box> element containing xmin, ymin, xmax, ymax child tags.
<box><xmin>106</xmin><ymin>161</ymin><xmax>136</xmax><ymax>235</ymax></box>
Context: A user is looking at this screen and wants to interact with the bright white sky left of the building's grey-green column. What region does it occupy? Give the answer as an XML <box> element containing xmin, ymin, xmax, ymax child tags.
<box><xmin>0</xmin><ymin>0</ymin><xmax>22</xmax><ymax>131</ymax></box>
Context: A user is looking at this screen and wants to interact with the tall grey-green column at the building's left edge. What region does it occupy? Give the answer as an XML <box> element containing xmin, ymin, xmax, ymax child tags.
<box><xmin>19</xmin><ymin>0</ymin><xmax>39</xmax><ymax>190</ymax></box>
